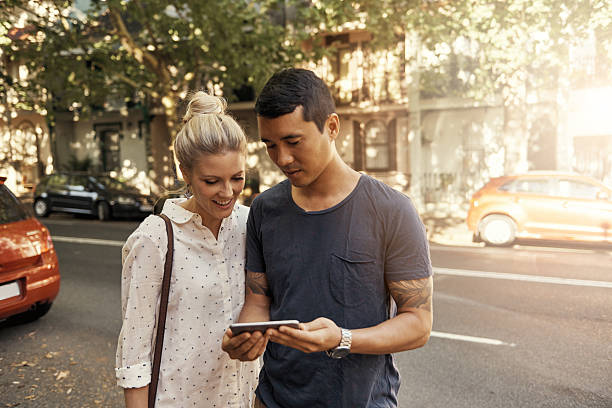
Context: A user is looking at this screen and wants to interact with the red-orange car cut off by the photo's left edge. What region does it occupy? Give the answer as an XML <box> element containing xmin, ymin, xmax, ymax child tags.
<box><xmin>0</xmin><ymin>177</ymin><xmax>60</xmax><ymax>321</ymax></box>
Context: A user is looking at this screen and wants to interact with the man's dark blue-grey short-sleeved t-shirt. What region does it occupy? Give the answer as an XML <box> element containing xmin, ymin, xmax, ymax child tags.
<box><xmin>247</xmin><ymin>175</ymin><xmax>432</xmax><ymax>408</ymax></box>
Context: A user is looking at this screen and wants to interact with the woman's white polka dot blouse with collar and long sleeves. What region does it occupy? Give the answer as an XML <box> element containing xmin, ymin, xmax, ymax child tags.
<box><xmin>115</xmin><ymin>198</ymin><xmax>259</xmax><ymax>408</ymax></box>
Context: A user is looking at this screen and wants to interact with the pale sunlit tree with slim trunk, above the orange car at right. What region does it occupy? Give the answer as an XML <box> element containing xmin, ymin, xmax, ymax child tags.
<box><xmin>288</xmin><ymin>0</ymin><xmax>612</xmax><ymax>171</ymax></box>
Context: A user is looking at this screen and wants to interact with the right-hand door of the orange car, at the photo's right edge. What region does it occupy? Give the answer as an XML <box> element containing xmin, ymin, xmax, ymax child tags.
<box><xmin>556</xmin><ymin>177</ymin><xmax>612</xmax><ymax>242</ymax></box>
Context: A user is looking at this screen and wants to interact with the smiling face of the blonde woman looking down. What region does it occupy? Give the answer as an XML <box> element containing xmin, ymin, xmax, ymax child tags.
<box><xmin>181</xmin><ymin>151</ymin><xmax>246</xmax><ymax>232</ymax></box>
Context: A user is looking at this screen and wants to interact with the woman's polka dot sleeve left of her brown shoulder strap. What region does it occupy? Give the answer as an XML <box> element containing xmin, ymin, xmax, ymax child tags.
<box><xmin>115</xmin><ymin>228</ymin><xmax>166</xmax><ymax>388</ymax></box>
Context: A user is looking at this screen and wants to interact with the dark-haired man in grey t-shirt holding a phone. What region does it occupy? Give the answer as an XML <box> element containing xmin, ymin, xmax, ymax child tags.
<box><xmin>223</xmin><ymin>69</ymin><xmax>433</xmax><ymax>408</ymax></box>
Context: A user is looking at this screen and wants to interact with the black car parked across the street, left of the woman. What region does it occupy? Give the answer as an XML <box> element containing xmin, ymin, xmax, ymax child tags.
<box><xmin>34</xmin><ymin>172</ymin><xmax>155</xmax><ymax>221</ymax></box>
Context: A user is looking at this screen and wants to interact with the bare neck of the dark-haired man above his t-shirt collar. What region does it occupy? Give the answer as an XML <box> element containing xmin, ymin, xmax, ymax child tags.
<box><xmin>291</xmin><ymin>156</ymin><xmax>361</xmax><ymax>211</ymax></box>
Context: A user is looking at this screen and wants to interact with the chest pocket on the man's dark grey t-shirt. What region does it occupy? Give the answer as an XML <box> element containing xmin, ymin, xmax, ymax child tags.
<box><xmin>329</xmin><ymin>253</ymin><xmax>383</xmax><ymax>307</ymax></box>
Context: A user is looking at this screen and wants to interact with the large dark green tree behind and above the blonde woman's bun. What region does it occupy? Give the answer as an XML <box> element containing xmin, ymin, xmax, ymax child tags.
<box><xmin>2</xmin><ymin>0</ymin><xmax>295</xmax><ymax>185</ymax></box>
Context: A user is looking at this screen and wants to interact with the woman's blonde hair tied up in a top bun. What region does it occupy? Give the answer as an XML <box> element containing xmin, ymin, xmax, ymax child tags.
<box><xmin>174</xmin><ymin>91</ymin><xmax>246</xmax><ymax>170</ymax></box>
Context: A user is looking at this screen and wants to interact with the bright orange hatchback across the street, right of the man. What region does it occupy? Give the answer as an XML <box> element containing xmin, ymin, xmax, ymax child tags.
<box><xmin>467</xmin><ymin>172</ymin><xmax>612</xmax><ymax>246</ymax></box>
